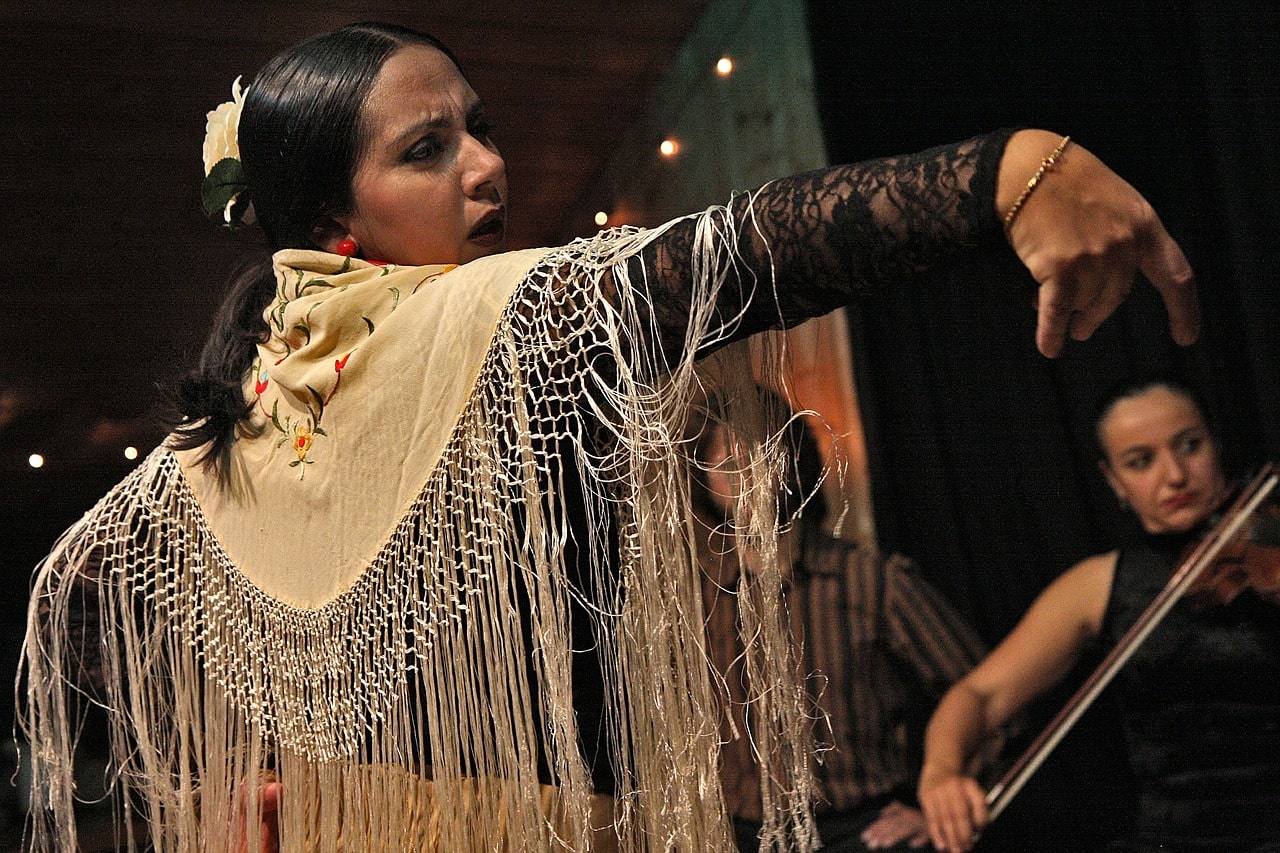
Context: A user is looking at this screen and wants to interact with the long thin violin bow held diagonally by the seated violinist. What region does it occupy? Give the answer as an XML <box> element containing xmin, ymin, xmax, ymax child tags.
<box><xmin>987</xmin><ymin>462</ymin><xmax>1280</xmax><ymax>820</ymax></box>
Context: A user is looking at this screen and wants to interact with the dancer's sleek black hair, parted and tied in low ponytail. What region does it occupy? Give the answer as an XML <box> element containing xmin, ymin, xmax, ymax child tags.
<box><xmin>166</xmin><ymin>22</ymin><xmax>462</xmax><ymax>476</ymax></box>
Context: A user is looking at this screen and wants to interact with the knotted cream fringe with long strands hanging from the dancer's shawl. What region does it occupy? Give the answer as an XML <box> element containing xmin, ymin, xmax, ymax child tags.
<box><xmin>23</xmin><ymin>197</ymin><xmax>814</xmax><ymax>850</ymax></box>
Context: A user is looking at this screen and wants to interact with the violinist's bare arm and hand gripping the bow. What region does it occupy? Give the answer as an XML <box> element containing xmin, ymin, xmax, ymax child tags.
<box><xmin>919</xmin><ymin>552</ymin><xmax>1116</xmax><ymax>852</ymax></box>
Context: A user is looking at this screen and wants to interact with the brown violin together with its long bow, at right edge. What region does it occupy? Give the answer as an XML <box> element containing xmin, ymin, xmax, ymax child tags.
<box><xmin>987</xmin><ymin>464</ymin><xmax>1280</xmax><ymax>820</ymax></box>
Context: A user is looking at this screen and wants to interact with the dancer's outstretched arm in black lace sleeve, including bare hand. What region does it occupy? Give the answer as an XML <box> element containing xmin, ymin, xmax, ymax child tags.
<box><xmin>645</xmin><ymin>131</ymin><xmax>1199</xmax><ymax>356</ymax></box>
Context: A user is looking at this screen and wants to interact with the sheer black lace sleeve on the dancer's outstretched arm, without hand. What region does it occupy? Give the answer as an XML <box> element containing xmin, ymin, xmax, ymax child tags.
<box><xmin>634</xmin><ymin>131</ymin><xmax>1012</xmax><ymax>353</ymax></box>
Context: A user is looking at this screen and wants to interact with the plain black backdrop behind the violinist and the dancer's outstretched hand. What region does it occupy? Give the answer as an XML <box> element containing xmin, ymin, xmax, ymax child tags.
<box><xmin>809</xmin><ymin>0</ymin><xmax>1280</xmax><ymax>852</ymax></box>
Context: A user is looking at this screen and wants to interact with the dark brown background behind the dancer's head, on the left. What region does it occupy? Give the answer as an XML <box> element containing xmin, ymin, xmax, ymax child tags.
<box><xmin>0</xmin><ymin>0</ymin><xmax>705</xmax><ymax>849</ymax></box>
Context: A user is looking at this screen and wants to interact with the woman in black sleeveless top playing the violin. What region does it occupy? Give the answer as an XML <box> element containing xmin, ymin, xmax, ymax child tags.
<box><xmin>919</xmin><ymin>378</ymin><xmax>1280</xmax><ymax>853</ymax></box>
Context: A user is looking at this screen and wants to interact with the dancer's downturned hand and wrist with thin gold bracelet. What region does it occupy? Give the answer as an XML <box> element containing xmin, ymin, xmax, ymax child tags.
<box><xmin>996</xmin><ymin>131</ymin><xmax>1199</xmax><ymax>357</ymax></box>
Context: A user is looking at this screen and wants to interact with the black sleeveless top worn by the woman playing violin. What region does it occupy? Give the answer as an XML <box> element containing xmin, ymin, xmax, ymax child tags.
<box><xmin>1102</xmin><ymin>527</ymin><xmax>1280</xmax><ymax>852</ymax></box>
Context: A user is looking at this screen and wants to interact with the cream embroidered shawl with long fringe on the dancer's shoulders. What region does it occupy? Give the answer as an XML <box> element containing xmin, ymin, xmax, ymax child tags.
<box><xmin>23</xmin><ymin>209</ymin><xmax>814</xmax><ymax>850</ymax></box>
